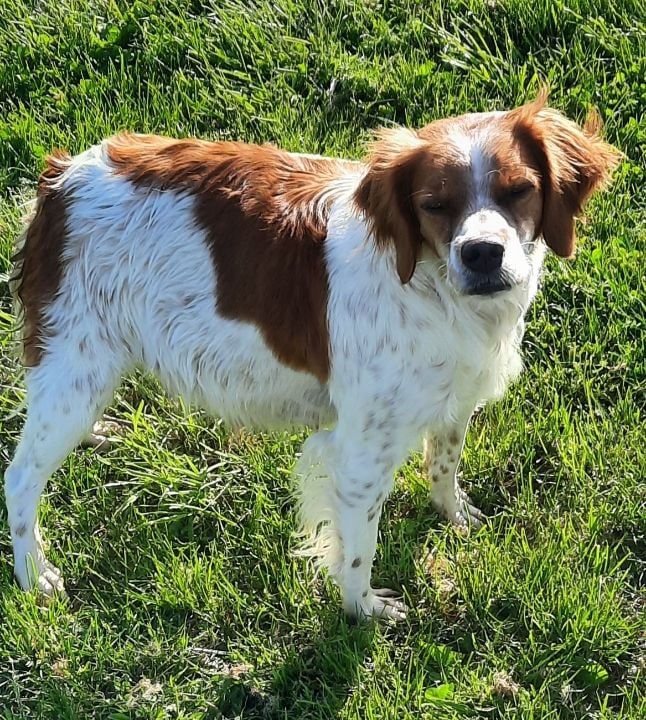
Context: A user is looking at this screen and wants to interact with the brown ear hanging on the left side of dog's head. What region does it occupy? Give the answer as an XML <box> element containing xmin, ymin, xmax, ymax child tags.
<box><xmin>355</xmin><ymin>128</ymin><xmax>423</xmax><ymax>284</ymax></box>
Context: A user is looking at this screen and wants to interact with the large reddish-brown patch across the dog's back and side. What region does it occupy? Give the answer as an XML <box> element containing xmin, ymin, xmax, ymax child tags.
<box><xmin>108</xmin><ymin>135</ymin><xmax>354</xmax><ymax>382</ymax></box>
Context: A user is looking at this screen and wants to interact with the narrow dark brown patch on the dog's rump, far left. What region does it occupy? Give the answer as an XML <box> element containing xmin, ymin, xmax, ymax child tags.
<box><xmin>12</xmin><ymin>153</ymin><xmax>70</xmax><ymax>367</ymax></box>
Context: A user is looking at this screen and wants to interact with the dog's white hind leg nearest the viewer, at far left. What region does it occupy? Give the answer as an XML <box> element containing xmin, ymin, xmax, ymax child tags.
<box><xmin>5</xmin><ymin>347</ymin><xmax>118</xmax><ymax>595</ymax></box>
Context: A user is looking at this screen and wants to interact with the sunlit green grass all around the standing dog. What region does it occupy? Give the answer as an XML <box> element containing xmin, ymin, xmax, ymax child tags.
<box><xmin>0</xmin><ymin>0</ymin><xmax>646</xmax><ymax>720</ymax></box>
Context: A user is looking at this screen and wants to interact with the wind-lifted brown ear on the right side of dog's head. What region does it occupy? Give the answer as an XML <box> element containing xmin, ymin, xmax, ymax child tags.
<box><xmin>512</xmin><ymin>93</ymin><xmax>621</xmax><ymax>257</ymax></box>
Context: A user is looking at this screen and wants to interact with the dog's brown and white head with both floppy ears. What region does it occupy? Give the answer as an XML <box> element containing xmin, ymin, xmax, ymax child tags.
<box><xmin>355</xmin><ymin>93</ymin><xmax>620</xmax><ymax>295</ymax></box>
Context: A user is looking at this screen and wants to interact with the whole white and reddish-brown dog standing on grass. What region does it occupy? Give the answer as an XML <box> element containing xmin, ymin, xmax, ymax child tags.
<box><xmin>5</xmin><ymin>96</ymin><xmax>618</xmax><ymax>618</ymax></box>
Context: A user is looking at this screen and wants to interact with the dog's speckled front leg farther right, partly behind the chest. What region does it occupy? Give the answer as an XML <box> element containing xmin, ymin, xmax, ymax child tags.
<box><xmin>424</xmin><ymin>416</ymin><xmax>485</xmax><ymax>530</ymax></box>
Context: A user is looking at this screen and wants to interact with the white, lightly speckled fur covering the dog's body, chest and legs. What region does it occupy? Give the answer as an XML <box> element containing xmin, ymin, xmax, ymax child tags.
<box><xmin>5</xmin><ymin>134</ymin><xmax>544</xmax><ymax>617</ymax></box>
